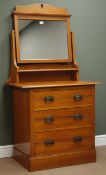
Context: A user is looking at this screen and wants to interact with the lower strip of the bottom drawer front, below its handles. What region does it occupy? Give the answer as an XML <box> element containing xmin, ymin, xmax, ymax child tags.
<box><xmin>34</xmin><ymin>137</ymin><xmax>91</xmax><ymax>155</ymax></box>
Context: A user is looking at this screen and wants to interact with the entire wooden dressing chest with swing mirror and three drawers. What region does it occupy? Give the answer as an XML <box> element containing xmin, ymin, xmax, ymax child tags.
<box><xmin>7</xmin><ymin>4</ymin><xmax>96</xmax><ymax>171</ymax></box>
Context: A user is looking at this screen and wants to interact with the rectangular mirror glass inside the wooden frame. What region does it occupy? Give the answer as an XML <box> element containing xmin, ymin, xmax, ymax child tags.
<box><xmin>19</xmin><ymin>20</ymin><xmax>68</xmax><ymax>60</ymax></box>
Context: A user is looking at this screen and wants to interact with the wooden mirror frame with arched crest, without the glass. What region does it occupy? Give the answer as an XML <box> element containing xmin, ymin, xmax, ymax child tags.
<box><xmin>13</xmin><ymin>4</ymin><xmax>72</xmax><ymax>63</ymax></box>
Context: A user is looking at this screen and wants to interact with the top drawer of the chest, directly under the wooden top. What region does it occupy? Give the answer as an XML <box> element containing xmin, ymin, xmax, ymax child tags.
<box><xmin>30</xmin><ymin>86</ymin><xmax>94</xmax><ymax>110</ymax></box>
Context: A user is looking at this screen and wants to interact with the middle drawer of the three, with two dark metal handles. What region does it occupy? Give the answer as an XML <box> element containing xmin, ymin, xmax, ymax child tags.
<box><xmin>32</xmin><ymin>107</ymin><xmax>94</xmax><ymax>132</ymax></box>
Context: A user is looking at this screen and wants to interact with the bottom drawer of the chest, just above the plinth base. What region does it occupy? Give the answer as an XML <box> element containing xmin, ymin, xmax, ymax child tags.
<box><xmin>34</xmin><ymin>128</ymin><xmax>92</xmax><ymax>155</ymax></box>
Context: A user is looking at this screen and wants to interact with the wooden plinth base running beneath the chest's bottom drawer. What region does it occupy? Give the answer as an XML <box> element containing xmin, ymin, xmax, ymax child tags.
<box><xmin>14</xmin><ymin>149</ymin><xmax>96</xmax><ymax>171</ymax></box>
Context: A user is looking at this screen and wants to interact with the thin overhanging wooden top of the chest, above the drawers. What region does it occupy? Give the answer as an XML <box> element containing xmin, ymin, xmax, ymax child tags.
<box><xmin>6</xmin><ymin>81</ymin><xmax>100</xmax><ymax>89</ymax></box>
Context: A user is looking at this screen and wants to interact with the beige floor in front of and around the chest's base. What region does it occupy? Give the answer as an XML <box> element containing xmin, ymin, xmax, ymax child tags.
<box><xmin>0</xmin><ymin>146</ymin><xmax>106</xmax><ymax>175</ymax></box>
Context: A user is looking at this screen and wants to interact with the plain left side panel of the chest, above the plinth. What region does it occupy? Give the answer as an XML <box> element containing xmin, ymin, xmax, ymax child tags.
<box><xmin>13</xmin><ymin>89</ymin><xmax>30</xmax><ymax>155</ymax></box>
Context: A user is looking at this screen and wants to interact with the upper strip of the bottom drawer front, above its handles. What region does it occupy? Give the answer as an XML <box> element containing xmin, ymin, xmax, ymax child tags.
<box><xmin>33</xmin><ymin>127</ymin><xmax>91</xmax><ymax>143</ymax></box>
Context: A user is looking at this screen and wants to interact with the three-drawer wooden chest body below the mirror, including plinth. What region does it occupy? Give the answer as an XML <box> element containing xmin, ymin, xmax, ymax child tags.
<box><xmin>13</xmin><ymin>82</ymin><xmax>96</xmax><ymax>171</ymax></box>
